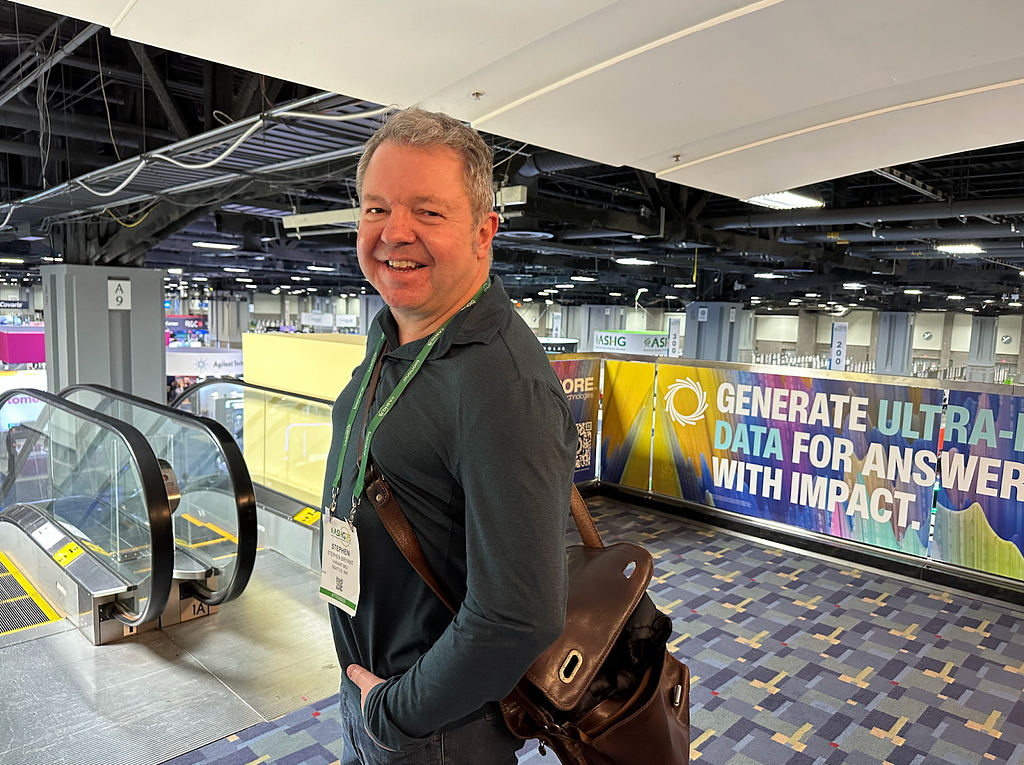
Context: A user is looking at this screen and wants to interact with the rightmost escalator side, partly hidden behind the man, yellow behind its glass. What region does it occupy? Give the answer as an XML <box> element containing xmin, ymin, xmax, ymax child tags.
<box><xmin>171</xmin><ymin>379</ymin><xmax>333</xmax><ymax>569</ymax></box>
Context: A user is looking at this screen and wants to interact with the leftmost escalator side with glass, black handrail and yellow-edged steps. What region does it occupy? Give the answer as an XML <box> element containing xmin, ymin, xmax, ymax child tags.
<box><xmin>0</xmin><ymin>389</ymin><xmax>175</xmax><ymax>645</ymax></box>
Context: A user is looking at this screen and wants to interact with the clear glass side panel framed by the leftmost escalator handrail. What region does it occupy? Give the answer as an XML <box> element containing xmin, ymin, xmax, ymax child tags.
<box><xmin>0</xmin><ymin>391</ymin><xmax>170</xmax><ymax>621</ymax></box>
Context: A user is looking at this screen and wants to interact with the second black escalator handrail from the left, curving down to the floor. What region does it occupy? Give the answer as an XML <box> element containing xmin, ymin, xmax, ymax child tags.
<box><xmin>57</xmin><ymin>384</ymin><xmax>258</xmax><ymax>605</ymax></box>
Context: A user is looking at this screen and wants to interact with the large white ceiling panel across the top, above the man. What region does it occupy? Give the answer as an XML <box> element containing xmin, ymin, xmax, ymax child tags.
<box><xmin>16</xmin><ymin>0</ymin><xmax>1024</xmax><ymax>198</ymax></box>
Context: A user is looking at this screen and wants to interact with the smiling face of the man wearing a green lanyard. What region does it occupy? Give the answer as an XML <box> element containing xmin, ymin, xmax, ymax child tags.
<box><xmin>356</xmin><ymin>141</ymin><xmax>498</xmax><ymax>335</ymax></box>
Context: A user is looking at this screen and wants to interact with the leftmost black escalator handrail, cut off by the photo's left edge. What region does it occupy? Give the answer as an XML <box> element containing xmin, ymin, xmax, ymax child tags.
<box><xmin>0</xmin><ymin>388</ymin><xmax>174</xmax><ymax>627</ymax></box>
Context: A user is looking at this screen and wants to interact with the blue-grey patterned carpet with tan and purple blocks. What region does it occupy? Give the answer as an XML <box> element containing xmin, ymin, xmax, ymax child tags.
<box><xmin>159</xmin><ymin>498</ymin><xmax>1024</xmax><ymax>765</ymax></box>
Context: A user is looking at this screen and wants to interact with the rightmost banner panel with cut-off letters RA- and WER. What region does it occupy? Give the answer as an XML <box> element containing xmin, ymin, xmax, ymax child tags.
<box><xmin>931</xmin><ymin>390</ymin><xmax>1024</xmax><ymax>580</ymax></box>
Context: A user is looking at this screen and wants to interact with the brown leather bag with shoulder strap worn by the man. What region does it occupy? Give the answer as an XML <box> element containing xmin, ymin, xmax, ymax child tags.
<box><xmin>367</xmin><ymin>470</ymin><xmax>690</xmax><ymax>765</ymax></box>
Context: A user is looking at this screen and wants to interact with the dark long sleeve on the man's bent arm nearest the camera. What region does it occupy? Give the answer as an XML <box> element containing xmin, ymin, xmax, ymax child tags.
<box><xmin>365</xmin><ymin>380</ymin><xmax>577</xmax><ymax>749</ymax></box>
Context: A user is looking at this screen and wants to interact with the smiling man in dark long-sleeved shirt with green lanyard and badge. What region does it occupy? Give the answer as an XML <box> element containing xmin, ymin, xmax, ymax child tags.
<box><xmin>322</xmin><ymin>109</ymin><xmax>577</xmax><ymax>765</ymax></box>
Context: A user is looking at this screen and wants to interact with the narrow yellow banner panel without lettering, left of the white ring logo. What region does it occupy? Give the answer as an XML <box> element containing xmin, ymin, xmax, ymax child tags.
<box><xmin>601</xmin><ymin>359</ymin><xmax>654</xmax><ymax>492</ymax></box>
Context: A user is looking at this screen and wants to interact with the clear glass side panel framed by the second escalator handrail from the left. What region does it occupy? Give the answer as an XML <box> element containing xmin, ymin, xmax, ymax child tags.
<box><xmin>61</xmin><ymin>386</ymin><xmax>255</xmax><ymax>606</ymax></box>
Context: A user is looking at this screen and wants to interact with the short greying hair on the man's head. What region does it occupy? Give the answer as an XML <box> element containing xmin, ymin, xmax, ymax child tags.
<box><xmin>355</xmin><ymin>107</ymin><xmax>495</xmax><ymax>221</ymax></box>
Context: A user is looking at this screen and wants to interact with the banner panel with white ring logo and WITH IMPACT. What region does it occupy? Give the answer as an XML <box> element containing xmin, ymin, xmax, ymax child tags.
<box><xmin>651</xmin><ymin>365</ymin><xmax>942</xmax><ymax>556</ymax></box>
